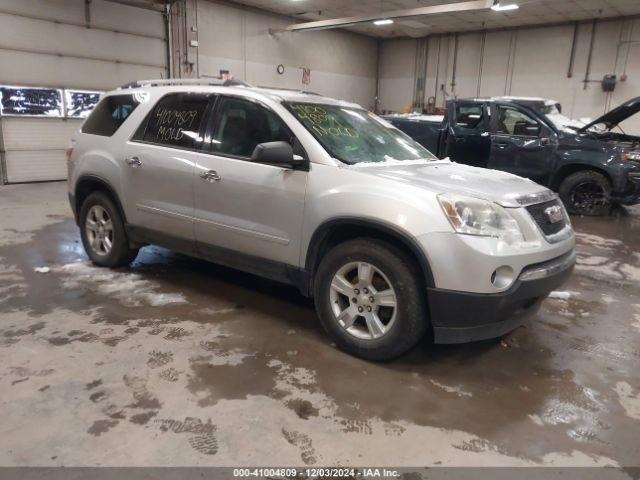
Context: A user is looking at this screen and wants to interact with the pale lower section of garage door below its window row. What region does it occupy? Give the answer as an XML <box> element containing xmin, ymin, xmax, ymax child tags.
<box><xmin>2</xmin><ymin>117</ymin><xmax>82</xmax><ymax>183</ymax></box>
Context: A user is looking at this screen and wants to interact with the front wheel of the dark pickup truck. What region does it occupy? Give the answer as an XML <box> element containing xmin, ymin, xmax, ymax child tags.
<box><xmin>559</xmin><ymin>170</ymin><xmax>611</xmax><ymax>216</ymax></box>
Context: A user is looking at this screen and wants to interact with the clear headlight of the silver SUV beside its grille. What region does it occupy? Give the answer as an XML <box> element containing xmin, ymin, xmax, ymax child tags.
<box><xmin>438</xmin><ymin>193</ymin><xmax>524</xmax><ymax>244</ymax></box>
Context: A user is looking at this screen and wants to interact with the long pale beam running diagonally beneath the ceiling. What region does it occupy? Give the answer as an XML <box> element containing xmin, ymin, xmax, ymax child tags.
<box><xmin>270</xmin><ymin>0</ymin><xmax>496</xmax><ymax>33</ymax></box>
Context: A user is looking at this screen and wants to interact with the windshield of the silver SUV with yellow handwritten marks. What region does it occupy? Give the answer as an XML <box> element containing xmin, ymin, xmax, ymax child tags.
<box><xmin>285</xmin><ymin>102</ymin><xmax>437</xmax><ymax>165</ymax></box>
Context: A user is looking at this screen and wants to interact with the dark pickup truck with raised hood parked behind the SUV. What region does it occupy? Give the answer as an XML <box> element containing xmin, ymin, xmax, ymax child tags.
<box><xmin>385</xmin><ymin>97</ymin><xmax>640</xmax><ymax>215</ymax></box>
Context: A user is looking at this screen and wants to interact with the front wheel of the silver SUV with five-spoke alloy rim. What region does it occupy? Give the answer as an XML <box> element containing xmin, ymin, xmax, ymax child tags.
<box><xmin>314</xmin><ymin>238</ymin><xmax>429</xmax><ymax>361</ymax></box>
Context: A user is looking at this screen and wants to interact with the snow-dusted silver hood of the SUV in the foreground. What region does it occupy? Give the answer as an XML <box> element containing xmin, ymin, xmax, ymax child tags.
<box><xmin>350</xmin><ymin>160</ymin><xmax>555</xmax><ymax>207</ymax></box>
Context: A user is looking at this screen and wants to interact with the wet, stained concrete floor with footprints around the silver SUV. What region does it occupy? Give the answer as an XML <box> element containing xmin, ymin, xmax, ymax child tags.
<box><xmin>0</xmin><ymin>183</ymin><xmax>640</xmax><ymax>466</ymax></box>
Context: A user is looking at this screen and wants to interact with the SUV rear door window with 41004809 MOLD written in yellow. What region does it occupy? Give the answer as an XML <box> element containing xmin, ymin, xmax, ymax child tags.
<box><xmin>135</xmin><ymin>92</ymin><xmax>212</xmax><ymax>150</ymax></box>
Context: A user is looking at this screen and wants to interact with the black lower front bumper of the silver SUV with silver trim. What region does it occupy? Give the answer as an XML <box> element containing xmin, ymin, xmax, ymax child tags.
<box><xmin>428</xmin><ymin>250</ymin><xmax>576</xmax><ymax>343</ymax></box>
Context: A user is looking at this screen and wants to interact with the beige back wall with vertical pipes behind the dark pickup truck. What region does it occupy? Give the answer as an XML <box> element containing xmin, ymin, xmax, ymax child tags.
<box><xmin>380</xmin><ymin>18</ymin><xmax>640</xmax><ymax>131</ymax></box>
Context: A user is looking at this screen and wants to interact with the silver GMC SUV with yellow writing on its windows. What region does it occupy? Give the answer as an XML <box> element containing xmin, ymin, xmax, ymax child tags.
<box><xmin>69</xmin><ymin>80</ymin><xmax>575</xmax><ymax>360</ymax></box>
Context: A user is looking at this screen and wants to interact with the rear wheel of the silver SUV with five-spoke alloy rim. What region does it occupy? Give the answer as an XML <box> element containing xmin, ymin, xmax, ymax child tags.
<box><xmin>79</xmin><ymin>192</ymin><xmax>138</xmax><ymax>268</ymax></box>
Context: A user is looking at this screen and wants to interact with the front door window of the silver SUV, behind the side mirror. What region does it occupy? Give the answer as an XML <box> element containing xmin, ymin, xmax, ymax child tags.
<box><xmin>211</xmin><ymin>97</ymin><xmax>293</xmax><ymax>158</ymax></box>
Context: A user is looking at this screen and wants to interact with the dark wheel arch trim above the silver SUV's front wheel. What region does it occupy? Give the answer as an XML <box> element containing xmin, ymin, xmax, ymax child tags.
<box><xmin>305</xmin><ymin>217</ymin><xmax>435</xmax><ymax>291</ymax></box>
